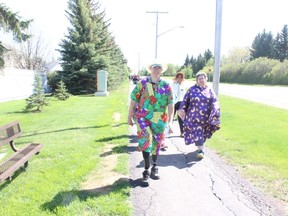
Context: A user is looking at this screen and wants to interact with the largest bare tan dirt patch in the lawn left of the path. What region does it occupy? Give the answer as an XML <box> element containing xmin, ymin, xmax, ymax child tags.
<box><xmin>81</xmin><ymin>145</ymin><xmax>127</xmax><ymax>194</ymax></box>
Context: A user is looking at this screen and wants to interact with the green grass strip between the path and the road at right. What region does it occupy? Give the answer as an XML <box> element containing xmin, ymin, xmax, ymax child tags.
<box><xmin>207</xmin><ymin>96</ymin><xmax>288</xmax><ymax>202</ymax></box>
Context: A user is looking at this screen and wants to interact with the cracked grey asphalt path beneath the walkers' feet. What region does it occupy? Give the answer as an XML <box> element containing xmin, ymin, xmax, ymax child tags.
<box><xmin>129</xmin><ymin>121</ymin><xmax>284</xmax><ymax>216</ymax></box>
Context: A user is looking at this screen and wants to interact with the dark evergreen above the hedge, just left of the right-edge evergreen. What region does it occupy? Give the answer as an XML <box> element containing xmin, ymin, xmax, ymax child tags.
<box><xmin>250</xmin><ymin>29</ymin><xmax>274</xmax><ymax>59</ymax></box>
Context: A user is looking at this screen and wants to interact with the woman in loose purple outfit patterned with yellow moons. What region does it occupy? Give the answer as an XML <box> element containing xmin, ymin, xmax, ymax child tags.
<box><xmin>178</xmin><ymin>71</ymin><xmax>220</xmax><ymax>159</ymax></box>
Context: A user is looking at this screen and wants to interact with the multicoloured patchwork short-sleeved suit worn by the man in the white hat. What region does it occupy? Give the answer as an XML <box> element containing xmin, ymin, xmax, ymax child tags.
<box><xmin>131</xmin><ymin>76</ymin><xmax>173</xmax><ymax>155</ymax></box>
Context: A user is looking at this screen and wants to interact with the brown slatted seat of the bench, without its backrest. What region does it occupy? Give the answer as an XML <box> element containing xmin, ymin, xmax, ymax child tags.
<box><xmin>0</xmin><ymin>143</ymin><xmax>43</xmax><ymax>183</ymax></box>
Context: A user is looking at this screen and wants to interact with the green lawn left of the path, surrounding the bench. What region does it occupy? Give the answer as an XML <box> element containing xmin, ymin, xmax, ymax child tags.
<box><xmin>0</xmin><ymin>82</ymin><xmax>131</xmax><ymax>216</ymax></box>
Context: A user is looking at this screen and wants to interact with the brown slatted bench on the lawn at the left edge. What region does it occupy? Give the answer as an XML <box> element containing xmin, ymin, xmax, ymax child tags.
<box><xmin>0</xmin><ymin>121</ymin><xmax>43</xmax><ymax>183</ymax></box>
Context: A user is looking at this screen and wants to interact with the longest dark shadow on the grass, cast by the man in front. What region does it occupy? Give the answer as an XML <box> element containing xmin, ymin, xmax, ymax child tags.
<box><xmin>41</xmin><ymin>178</ymin><xmax>131</xmax><ymax>213</ymax></box>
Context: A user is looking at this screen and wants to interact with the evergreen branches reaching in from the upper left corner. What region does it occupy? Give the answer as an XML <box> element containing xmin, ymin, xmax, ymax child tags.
<box><xmin>0</xmin><ymin>3</ymin><xmax>32</xmax><ymax>69</ymax></box>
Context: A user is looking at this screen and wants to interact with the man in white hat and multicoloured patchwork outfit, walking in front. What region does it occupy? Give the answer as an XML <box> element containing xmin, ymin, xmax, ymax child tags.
<box><xmin>128</xmin><ymin>63</ymin><xmax>174</xmax><ymax>186</ymax></box>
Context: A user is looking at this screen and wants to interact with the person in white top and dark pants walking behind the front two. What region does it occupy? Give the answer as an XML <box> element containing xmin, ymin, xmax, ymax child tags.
<box><xmin>172</xmin><ymin>72</ymin><xmax>187</xmax><ymax>137</ymax></box>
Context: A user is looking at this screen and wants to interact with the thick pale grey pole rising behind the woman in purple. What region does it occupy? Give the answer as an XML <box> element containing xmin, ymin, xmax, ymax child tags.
<box><xmin>213</xmin><ymin>0</ymin><xmax>222</xmax><ymax>95</ymax></box>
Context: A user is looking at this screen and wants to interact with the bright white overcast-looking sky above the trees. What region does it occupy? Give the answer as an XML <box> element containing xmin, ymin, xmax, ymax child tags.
<box><xmin>0</xmin><ymin>0</ymin><xmax>288</xmax><ymax>71</ymax></box>
